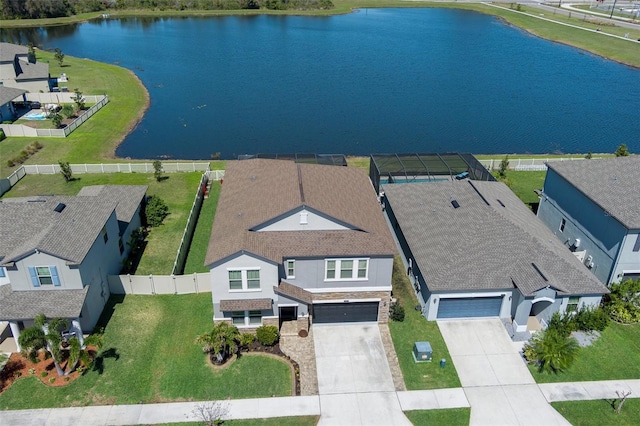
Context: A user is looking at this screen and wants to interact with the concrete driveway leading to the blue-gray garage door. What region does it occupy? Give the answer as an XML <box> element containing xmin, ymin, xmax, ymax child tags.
<box><xmin>438</xmin><ymin>319</ymin><xmax>569</xmax><ymax>426</ymax></box>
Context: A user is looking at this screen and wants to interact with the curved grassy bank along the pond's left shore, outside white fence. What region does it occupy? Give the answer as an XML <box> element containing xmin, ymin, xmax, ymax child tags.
<box><xmin>0</xmin><ymin>51</ymin><xmax>148</xmax><ymax>177</ymax></box>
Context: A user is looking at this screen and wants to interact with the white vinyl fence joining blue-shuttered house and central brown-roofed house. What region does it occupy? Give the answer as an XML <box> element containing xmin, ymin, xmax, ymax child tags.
<box><xmin>108</xmin><ymin>272</ymin><xmax>211</xmax><ymax>294</ymax></box>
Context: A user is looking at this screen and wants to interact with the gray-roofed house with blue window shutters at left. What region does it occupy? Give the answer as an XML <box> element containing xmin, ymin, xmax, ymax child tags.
<box><xmin>0</xmin><ymin>186</ymin><xmax>147</xmax><ymax>348</ymax></box>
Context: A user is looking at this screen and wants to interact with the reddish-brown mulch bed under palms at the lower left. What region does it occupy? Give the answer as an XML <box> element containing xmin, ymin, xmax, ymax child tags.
<box><xmin>0</xmin><ymin>351</ymin><xmax>95</xmax><ymax>394</ymax></box>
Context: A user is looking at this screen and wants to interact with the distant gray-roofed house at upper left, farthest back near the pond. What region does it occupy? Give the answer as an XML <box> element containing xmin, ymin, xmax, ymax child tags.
<box><xmin>0</xmin><ymin>43</ymin><xmax>51</xmax><ymax>93</ymax></box>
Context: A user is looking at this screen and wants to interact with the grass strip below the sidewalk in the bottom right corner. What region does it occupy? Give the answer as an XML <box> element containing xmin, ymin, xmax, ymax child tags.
<box><xmin>551</xmin><ymin>395</ymin><xmax>640</xmax><ymax>426</ymax></box>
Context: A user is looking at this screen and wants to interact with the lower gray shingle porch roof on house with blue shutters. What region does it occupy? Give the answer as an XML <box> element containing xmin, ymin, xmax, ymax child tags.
<box><xmin>0</xmin><ymin>284</ymin><xmax>89</xmax><ymax>321</ymax></box>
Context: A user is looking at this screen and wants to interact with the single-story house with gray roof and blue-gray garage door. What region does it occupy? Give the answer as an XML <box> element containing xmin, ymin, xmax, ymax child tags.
<box><xmin>383</xmin><ymin>180</ymin><xmax>608</xmax><ymax>331</ymax></box>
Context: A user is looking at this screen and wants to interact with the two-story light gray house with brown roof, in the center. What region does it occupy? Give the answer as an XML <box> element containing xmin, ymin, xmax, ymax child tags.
<box><xmin>205</xmin><ymin>159</ymin><xmax>396</xmax><ymax>329</ymax></box>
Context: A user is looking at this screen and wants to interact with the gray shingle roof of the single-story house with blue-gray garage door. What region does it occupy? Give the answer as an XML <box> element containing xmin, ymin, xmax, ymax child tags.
<box><xmin>383</xmin><ymin>181</ymin><xmax>608</xmax><ymax>296</ymax></box>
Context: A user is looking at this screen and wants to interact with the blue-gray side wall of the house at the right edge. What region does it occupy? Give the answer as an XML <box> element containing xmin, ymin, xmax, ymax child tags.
<box><xmin>538</xmin><ymin>170</ymin><xmax>627</xmax><ymax>284</ymax></box>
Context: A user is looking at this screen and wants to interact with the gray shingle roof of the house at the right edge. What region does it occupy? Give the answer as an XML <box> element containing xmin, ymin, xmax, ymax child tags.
<box><xmin>547</xmin><ymin>155</ymin><xmax>640</xmax><ymax>229</ymax></box>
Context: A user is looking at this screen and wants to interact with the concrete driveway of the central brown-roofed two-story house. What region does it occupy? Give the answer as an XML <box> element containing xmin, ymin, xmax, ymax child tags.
<box><xmin>313</xmin><ymin>323</ymin><xmax>411</xmax><ymax>426</ymax></box>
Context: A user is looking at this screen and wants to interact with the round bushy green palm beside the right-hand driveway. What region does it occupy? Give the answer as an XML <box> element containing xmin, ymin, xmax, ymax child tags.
<box><xmin>531</xmin><ymin>329</ymin><xmax>580</xmax><ymax>373</ymax></box>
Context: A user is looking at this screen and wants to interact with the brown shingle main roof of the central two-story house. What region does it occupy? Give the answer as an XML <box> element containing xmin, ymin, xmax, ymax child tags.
<box><xmin>205</xmin><ymin>159</ymin><xmax>395</xmax><ymax>265</ymax></box>
